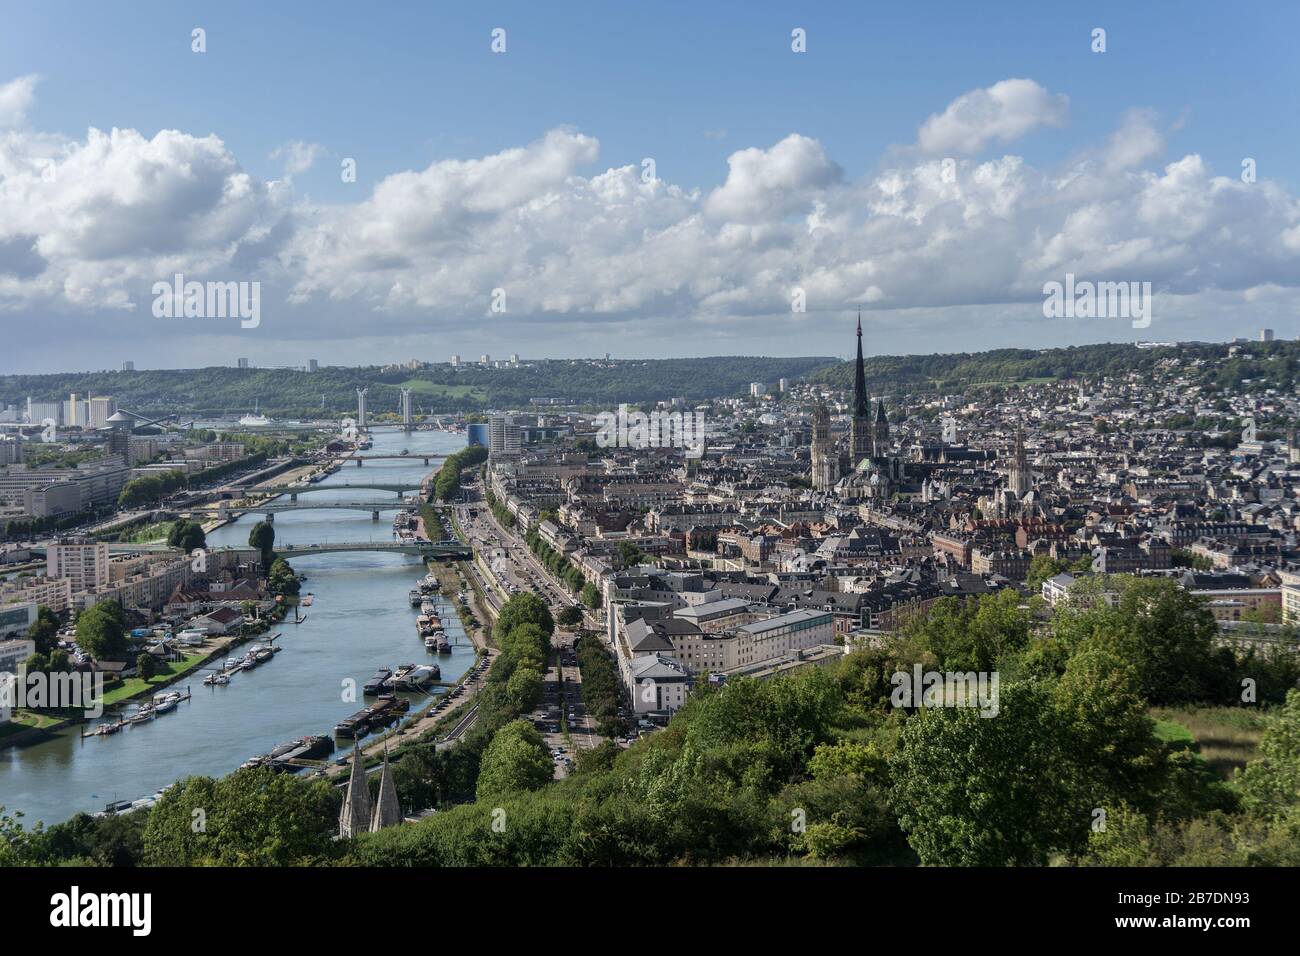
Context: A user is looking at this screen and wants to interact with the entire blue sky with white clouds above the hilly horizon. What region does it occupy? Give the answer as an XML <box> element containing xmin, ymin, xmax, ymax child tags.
<box><xmin>0</xmin><ymin>0</ymin><xmax>1300</xmax><ymax>373</ymax></box>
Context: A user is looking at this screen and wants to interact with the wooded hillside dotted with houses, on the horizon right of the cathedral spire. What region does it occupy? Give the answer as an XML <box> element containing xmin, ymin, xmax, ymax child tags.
<box><xmin>809</xmin><ymin>341</ymin><xmax>1300</xmax><ymax>394</ymax></box>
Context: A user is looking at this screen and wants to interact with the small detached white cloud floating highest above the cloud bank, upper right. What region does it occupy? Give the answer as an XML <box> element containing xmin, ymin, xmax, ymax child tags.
<box><xmin>917</xmin><ymin>79</ymin><xmax>1070</xmax><ymax>156</ymax></box>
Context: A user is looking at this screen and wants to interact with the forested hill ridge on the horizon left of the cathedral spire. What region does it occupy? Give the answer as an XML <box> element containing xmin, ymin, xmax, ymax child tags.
<box><xmin>0</xmin><ymin>356</ymin><xmax>836</xmax><ymax>418</ymax></box>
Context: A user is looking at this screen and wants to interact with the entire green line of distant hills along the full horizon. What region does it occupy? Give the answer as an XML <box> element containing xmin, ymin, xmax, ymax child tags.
<box><xmin>0</xmin><ymin>341</ymin><xmax>1300</xmax><ymax>418</ymax></box>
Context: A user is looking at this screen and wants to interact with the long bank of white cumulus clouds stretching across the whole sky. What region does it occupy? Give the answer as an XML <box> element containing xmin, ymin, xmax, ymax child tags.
<box><xmin>0</xmin><ymin>74</ymin><xmax>1300</xmax><ymax>351</ymax></box>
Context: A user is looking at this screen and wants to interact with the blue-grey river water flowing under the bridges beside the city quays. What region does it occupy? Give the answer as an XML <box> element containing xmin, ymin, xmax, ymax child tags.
<box><xmin>0</xmin><ymin>431</ymin><xmax>475</xmax><ymax>826</ymax></box>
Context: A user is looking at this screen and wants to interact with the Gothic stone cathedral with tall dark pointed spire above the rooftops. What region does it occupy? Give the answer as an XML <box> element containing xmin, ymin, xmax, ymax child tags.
<box><xmin>810</xmin><ymin>313</ymin><xmax>906</xmax><ymax>501</ymax></box>
